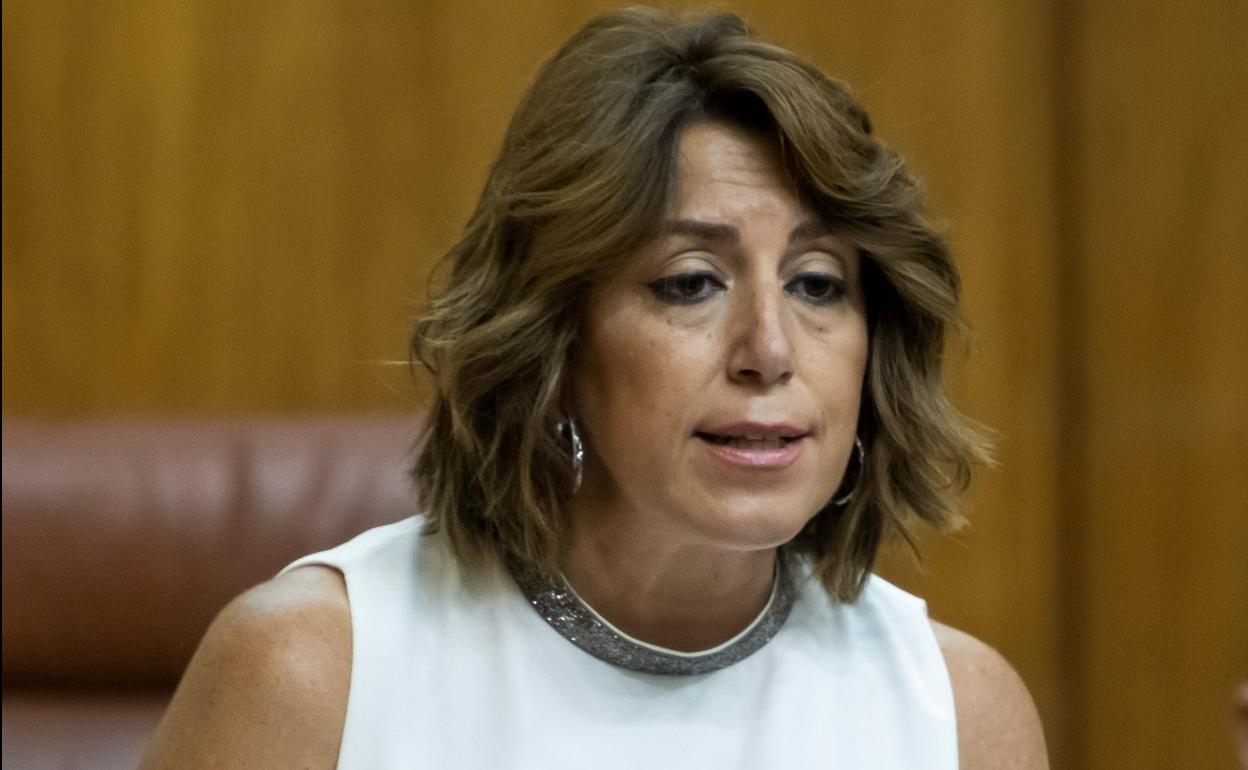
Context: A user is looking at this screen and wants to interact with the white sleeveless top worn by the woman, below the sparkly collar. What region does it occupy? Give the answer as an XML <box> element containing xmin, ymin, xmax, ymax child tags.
<box><xmin>283</xmin><ymin>517</ymin><xmax>957</xmax><ymax>770</ymax></box>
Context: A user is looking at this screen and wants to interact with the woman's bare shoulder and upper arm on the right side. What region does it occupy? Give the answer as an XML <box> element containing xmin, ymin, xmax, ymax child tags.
<box><xmin>931</xmin><ymin>620</ymin><xmax>1048</xmax><ymax>770</ymax></box>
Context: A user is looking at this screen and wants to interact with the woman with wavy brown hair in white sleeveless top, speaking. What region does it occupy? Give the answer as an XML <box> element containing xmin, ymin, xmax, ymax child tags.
<box><xmin>147</xmin><ymin>10</ymin><xmax>1046</xmax><ymax>770</ymax></box>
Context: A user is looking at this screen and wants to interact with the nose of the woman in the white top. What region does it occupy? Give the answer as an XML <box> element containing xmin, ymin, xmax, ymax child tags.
<box><xmin>729</xmin><ymin>282</ymin><xmax>794</xmax><ymax>387</ymax></box>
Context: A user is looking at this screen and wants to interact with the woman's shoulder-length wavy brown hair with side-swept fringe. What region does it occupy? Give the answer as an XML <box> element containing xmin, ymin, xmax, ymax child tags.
<box><xmin>411</xmin><ymin>9</ymin><xmax>986</xmax><ymax>602</ymax></box>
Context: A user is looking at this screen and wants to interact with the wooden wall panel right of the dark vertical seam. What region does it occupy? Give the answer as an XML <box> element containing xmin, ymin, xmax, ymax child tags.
<box><xmin>1063</xmin><ymin>0</ymin><xmax>1248</xmax><ymax>769</ymax></box>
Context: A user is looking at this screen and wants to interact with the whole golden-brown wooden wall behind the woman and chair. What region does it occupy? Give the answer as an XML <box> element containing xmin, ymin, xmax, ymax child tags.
<box><xmin>2</xmin><ymin>0</ymin><xmax>1248</xmax><ymax>769</ymax></box>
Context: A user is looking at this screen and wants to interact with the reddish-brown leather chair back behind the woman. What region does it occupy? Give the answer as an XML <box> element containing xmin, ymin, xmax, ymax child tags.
<box><xmin>2</xmin><ymin>417</ymin><xmax>417</xmax><ymax>769</ymax></box>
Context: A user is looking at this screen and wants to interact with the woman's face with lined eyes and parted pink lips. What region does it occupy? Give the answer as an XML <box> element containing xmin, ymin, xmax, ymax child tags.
<box><xmin>573</xmin><ymin>122</ymin><xmax>867</xmax><ymax>550</ymax></box>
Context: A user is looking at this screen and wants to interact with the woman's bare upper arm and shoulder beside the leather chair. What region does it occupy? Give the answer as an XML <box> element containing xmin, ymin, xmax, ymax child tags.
<box><xmin>141</xmin><ymin>567</ymin><xmax>351</xmax><ymax>770</ymax></box>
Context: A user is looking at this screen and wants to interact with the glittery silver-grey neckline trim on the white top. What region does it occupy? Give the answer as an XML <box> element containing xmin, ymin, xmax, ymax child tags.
<box><xmin>508</xmin><ymin>549</ymin><xmax>795</xmax><ymax>676</ymax></box>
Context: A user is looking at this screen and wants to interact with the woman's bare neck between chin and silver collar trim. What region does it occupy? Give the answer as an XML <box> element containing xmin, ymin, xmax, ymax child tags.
<box><xmin>563</xmin><ymin>499</ymin><xmax>776</xmax><ymax>651</ymax></box>
